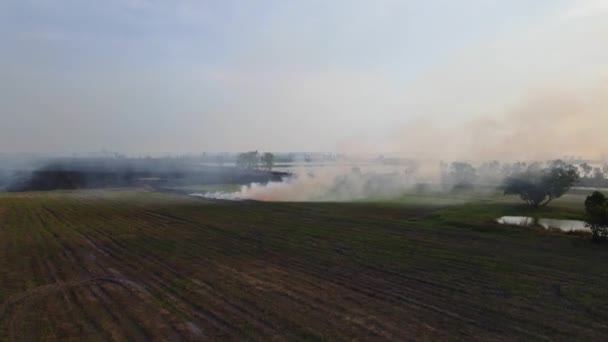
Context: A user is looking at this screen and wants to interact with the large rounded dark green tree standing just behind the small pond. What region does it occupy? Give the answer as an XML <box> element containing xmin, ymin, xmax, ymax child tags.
<box><xmin>504</xmin><ymin>165</ymin><xmax>579</xmax><ymax>208</ymax></box>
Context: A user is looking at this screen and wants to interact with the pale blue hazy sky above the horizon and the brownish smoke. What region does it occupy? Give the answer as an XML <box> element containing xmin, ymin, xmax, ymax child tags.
<box><xmin>0</xmin><ymin>0</ymin><xmax>608</xmax><ymax>153</ymax></box>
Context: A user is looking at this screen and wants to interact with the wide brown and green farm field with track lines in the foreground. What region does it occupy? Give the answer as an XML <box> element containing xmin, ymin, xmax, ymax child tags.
<box><xmin>0</xmin><ymin>190</ymin><xmax>608</xmax><ymax>341</ymax></box>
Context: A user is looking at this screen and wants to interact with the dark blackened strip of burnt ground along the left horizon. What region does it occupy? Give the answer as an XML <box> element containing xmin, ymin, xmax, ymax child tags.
<box><xmin>5</xmin><ymin>158</ymin><xmax>290</xmax><ymax>192</ymax></box>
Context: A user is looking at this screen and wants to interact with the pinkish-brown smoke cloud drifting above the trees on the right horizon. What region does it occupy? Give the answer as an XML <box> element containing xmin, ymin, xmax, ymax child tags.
<box><xmin>390</xmin><ymin>84</ymin><xmax>608</xmax><ymax>161</ymax></box>
